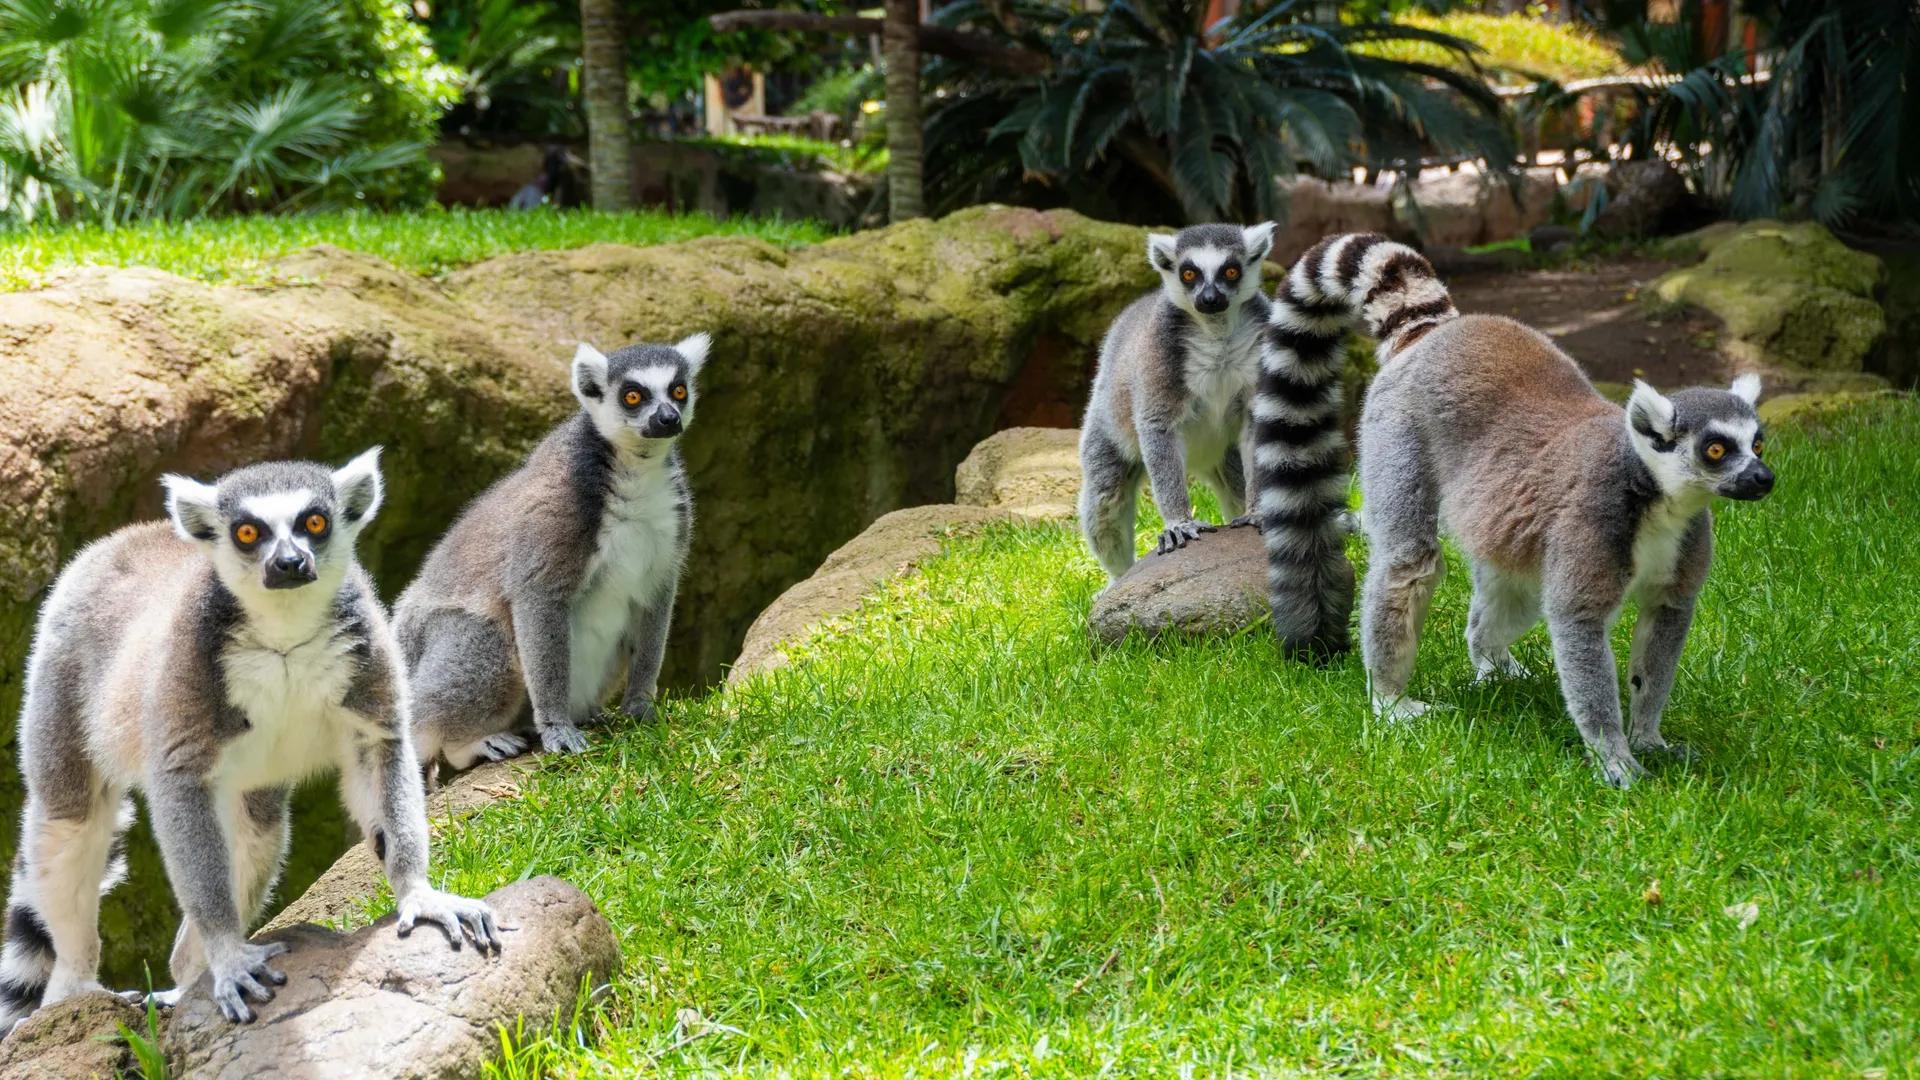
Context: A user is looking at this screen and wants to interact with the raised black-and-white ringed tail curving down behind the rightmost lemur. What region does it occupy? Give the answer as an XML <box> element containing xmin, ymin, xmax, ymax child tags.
<box><xmin>1252</xmin><ymin>233</ymin><xmax>1459</xmax><ymax>655</ymax></box>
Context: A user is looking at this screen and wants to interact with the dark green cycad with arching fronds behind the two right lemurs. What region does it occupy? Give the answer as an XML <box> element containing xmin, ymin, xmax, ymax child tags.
<box><xmin>927</xmin><ymin>0</ymin><xmax>1513</xmax><ymax>221</ymax></box>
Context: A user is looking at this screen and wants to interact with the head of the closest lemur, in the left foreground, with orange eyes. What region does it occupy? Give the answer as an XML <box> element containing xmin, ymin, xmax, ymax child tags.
<box><xmin>161</xmin><ymin>446</ymin><xmax>384</xmax><ymax>594</ymax></box>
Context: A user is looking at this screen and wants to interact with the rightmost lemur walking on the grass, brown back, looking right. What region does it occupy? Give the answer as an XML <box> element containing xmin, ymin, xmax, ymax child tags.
<box><xmin>1296</xmin><ymin>234</ymin><xmax>1774</xmax><ymax>788</ymax></box>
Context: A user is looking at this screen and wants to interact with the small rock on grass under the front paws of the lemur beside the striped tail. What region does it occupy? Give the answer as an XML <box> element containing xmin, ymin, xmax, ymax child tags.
<box><xmin>1089</xmin><ymin>528</ymin><xmax>1267</xmax><ymax>642</ymax></box>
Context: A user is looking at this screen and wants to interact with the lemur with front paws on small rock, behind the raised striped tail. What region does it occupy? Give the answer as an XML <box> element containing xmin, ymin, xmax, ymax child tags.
<box><xmin>1079</xmin><ymin>221</ymin><xmax>1273</xmax><ymax>580</ymax></box>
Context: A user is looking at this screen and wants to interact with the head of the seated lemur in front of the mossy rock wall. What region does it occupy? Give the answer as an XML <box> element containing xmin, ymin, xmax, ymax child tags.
<box><xmin>572</xmin><ymin>334</ymin><xmax>712</xmax><ymax>448</ymax></box>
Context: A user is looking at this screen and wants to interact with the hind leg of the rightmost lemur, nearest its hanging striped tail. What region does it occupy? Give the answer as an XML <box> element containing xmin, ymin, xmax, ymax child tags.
<box><xmin>1359</xmin><ymin>423</ymin><xmax>1446</xmax><ymax>719</ymax></box>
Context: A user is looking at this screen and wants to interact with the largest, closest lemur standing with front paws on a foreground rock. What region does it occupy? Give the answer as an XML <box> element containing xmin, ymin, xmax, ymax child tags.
<box><xmin>0</xmin><ymin>450</ymin><xmax>499</xmax><ymax>1030</ymax></box>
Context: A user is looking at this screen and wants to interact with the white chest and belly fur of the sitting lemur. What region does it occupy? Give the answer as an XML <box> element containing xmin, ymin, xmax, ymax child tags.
<box><xmin>568</xmin><ymin>441</ymin><xmax>682</xmax><ymax>715</ymax></box>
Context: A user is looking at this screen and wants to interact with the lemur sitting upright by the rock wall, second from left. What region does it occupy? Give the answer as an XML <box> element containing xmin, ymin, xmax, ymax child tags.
<box><xmin>394</xmin><ymin>334</ymin><xmax>710</xmax><ymax>771</ymax></box>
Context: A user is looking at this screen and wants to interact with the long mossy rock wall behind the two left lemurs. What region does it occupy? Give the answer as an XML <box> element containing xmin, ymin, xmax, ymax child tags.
<box><xmin>0</xmin><ymin>208</ymin><xmax>1152</xmax><ymax>986</ymax></box>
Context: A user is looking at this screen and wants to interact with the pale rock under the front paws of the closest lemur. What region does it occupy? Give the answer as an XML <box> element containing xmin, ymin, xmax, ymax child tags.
<box><xmin>165</xmin><ymin>876</ymin><xmax>620</xmax><ymax>1080</ymax></box>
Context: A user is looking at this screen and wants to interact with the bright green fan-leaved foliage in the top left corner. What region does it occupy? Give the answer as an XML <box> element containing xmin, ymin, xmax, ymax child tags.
<box><xmin>0</xmin><ymin>0</ymin><xmax>451</xmax><ymax>225</ymax></box>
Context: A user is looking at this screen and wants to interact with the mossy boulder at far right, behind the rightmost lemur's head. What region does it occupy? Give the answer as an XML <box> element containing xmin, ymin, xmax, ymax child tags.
<box><xmin>1651</xmin><ymin>221</ymin><xmax>1887</xmax><ymax>371</ymax></box>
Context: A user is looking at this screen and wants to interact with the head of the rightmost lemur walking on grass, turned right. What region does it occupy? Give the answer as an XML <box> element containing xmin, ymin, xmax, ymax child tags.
<box><xmin>1626</xmin><ymin>375</ymin><xmax>1774</xmax><ymax>500</ymax></box>
